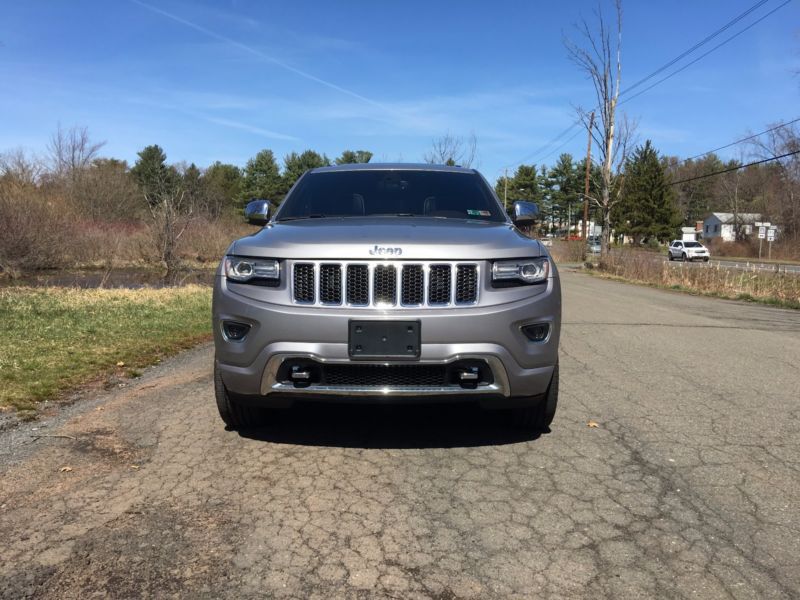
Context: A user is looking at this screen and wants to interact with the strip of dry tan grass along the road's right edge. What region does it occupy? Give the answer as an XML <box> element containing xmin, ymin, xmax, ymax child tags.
<box><xmin>599</xmin><ymin>252</ymin><xmax>800</xmax><ymax>308</ymax></box>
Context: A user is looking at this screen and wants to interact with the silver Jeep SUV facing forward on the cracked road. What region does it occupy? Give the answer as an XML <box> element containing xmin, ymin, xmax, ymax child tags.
<box><xmin>213</xmin><ymin>164</ymin><xmax>561</xmax><ymax>429</ymax></box>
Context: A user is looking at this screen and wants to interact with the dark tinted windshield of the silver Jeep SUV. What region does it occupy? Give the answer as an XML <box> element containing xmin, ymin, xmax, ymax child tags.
<box><xmin>276</xmin><ymin>169</ymin><xmax>506</xmax><ymax>221</ymax></box>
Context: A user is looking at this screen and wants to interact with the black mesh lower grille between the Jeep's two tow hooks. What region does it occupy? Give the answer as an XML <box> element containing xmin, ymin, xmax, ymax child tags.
<box><xmin>322</xmin><ymin>365</ymin><xmax>447</xmax><ymax>387</ymax></box>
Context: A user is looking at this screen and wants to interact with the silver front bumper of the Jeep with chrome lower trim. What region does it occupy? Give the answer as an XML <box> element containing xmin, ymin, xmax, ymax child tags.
<box><xmin>213</xmin><ymin>274</ymin><xmax>561</xmax><ymax>407</ymax></box>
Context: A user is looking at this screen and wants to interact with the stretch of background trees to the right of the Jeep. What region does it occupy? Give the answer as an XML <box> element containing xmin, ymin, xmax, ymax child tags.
<box><xmin>495</xmin><ymin>126</ymin><xmax>800</xmax><ymax>245</ymax></box>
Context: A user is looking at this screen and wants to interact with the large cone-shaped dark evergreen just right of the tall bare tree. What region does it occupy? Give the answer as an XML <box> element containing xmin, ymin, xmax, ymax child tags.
<box><xmin>612</xmin><ymin>140</ymin><xmax>681</xmax><ymax>245</ymax></box>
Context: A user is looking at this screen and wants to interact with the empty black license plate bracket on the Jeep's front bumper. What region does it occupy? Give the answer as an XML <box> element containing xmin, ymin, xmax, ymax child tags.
<box><xmin>347</xmin><ymin>321</ymin><xmax>421</xmax><ymax>360</ymax></box>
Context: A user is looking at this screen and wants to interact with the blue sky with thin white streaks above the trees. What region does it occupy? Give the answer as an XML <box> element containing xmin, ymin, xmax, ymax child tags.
<box><xmin>0</xmin><ymin>0</ymin><xmax>800</xmax><ymax>180</ymax></box>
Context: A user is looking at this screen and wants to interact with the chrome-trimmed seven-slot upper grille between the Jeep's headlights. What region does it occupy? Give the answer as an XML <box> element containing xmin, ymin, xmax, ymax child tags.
<box><xmin>292</xmin><ymin>261</ymin><xmax>480</xmax><ymax>307</ymax></box>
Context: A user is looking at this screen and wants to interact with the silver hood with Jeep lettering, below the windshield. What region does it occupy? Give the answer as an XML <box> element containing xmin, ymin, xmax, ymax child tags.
<box><xmin>232</xmin><ymin>217</ymin><xmax>545</xmax><ymax>260</ymax></box>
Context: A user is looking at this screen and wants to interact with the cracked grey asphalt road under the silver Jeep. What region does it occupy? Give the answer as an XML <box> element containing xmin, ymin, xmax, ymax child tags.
<box><xmin>0</xmin><ymin>273</ymin><xmax>800</xmax><ymax>599</ymax></box>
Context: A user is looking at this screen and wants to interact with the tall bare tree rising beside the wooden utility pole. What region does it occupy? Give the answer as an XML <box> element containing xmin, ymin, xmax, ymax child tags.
<box><xmin>564</xmin><ymin>0</ymin><xmax>636</xmax><ymax>257</ymax></box>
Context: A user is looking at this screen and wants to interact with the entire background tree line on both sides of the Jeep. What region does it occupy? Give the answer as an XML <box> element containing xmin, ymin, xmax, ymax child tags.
<box><xmin>0</xmin><ymin>126</ymin><xmax>800</xmax><ymax>271</ymax></box>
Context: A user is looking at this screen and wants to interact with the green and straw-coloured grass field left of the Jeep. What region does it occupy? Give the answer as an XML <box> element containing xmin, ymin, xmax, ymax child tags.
<box><xmin>0</xmin><ymin>285</ymin><xmax>211</xmax><ymax>411</ymax></box>
